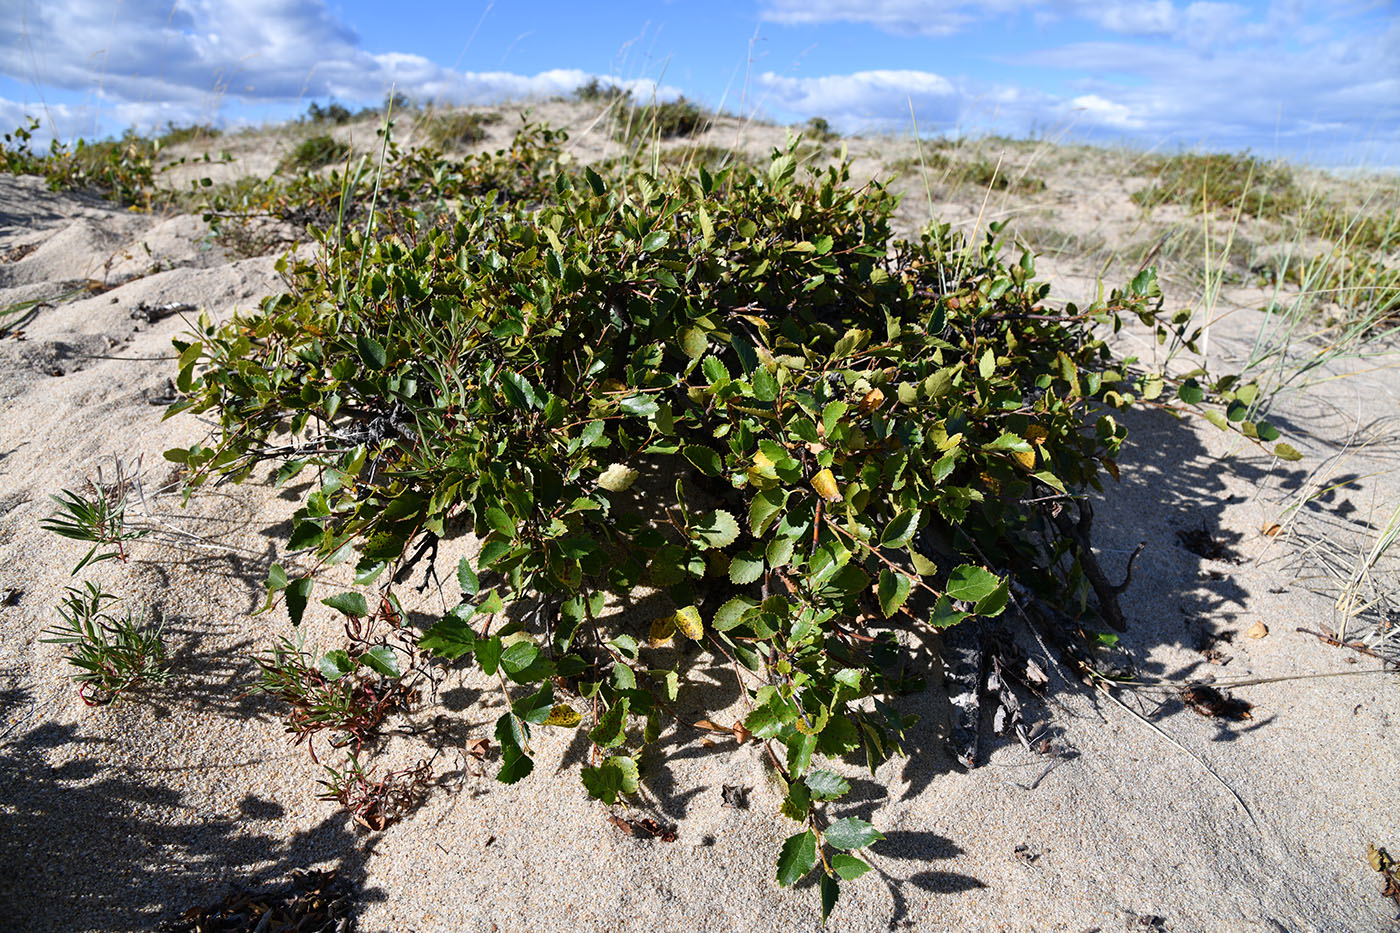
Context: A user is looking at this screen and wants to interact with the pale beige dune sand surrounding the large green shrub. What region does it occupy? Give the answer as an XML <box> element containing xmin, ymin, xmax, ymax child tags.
<box><xmin>0</xmin><ymin>103</ymin><xmax>1400</xmax><ymax>930</ymax></box>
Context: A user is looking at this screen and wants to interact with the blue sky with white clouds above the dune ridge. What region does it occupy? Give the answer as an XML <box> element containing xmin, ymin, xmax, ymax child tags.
<box><xmin>0</xmin><ymin>0</ymin><xmax>1400</xmax><ymax>167</ymax></box>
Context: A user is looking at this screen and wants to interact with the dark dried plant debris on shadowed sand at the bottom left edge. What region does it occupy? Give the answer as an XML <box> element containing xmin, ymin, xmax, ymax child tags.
<box><xmin>160</xmin><ymin>869</ymin><xmax>354</xmax><ymax>933</ymax></box>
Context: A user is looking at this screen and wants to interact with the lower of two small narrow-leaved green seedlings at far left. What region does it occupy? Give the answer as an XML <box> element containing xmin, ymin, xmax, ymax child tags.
<box><xmin>42</xmin><ymin>583</ymin><xmax>169</xmax><ymax>706</ymax></box>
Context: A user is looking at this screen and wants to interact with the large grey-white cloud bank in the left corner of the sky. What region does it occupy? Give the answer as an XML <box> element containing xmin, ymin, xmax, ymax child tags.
<box><xmin>0</xmin><ymin>0</ymin><xmax>679</xmax><ymax>133</ymax></box>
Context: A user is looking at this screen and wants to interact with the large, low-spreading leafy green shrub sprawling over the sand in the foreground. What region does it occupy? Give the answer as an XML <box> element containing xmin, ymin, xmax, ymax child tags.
<box><xmin>167</xmin><ymin>136</ymin><xmax>1288</xmax><ymax>916</ymax></box>
